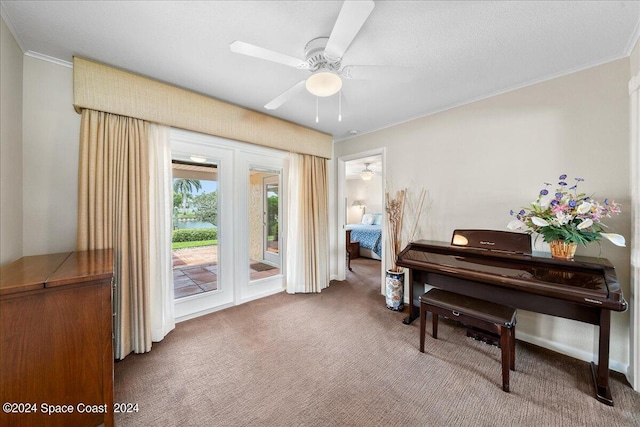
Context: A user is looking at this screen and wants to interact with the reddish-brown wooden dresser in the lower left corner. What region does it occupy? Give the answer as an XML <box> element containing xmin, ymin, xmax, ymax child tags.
<box><xmin>0</xmin><ymin>249</ymin><xmax>113</xmax><ymax>426</ymax></box>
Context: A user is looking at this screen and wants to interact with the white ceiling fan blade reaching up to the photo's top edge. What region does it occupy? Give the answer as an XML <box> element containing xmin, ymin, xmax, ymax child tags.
<box><xmin>324</xmin><ymin>0</ymin><xmax>375</xmax><ymax>61</ymax></box>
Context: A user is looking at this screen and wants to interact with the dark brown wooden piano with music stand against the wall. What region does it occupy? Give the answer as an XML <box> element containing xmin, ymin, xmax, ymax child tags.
<box><xmin>397</xmin><ymin>230</ymin><xmax>627</xmax><ymax>406</ymax></box>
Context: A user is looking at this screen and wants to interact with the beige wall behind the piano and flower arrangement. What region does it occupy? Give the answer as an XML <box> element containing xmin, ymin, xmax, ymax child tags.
<box><xmin>334</xmin><ymin>58</ymin><xmax>630</xmax><ymax>372</ymax></box>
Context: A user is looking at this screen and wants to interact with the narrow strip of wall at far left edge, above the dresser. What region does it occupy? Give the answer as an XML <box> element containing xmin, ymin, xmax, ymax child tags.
<box><xmin>0</xmin><ymin>19</ymin><xmax>22</xmax><ymax>265</ymax></box>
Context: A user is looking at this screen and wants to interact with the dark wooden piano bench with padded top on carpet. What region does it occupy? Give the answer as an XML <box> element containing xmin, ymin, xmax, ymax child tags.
<box><xmin>420</xmin><ymin>289</ymin><xmax>516</xmax><ymax>392</ymax></box>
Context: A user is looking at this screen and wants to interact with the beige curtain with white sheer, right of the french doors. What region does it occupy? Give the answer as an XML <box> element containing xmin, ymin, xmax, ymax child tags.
<box><xmin>287</xmin><ymin>153</ymin><xmax>329</xmax><ymax>293</ymax></box>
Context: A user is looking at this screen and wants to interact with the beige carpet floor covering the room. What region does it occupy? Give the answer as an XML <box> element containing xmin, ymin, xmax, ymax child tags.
<box><xmin>115</xmin><ymin>258</ymin><xmax>640</xmax><ymax>426</ymax></box>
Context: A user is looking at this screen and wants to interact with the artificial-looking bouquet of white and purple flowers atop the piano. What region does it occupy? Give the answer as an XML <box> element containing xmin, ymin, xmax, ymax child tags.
<box><xmin>507</xmin><ymin>175</ymin><xmax>625</xmax><ymax>246</ymax></box>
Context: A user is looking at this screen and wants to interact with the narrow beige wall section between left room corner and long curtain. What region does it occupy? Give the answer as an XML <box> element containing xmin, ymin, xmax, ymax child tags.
<box><xmin>23</xmin><ymin>56</ymin><xmax>80</xmax><ymax>255</ymax></box>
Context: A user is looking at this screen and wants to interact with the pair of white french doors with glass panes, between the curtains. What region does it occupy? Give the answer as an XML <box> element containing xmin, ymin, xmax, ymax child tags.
<box><xmin>171</xmin><ymin>130</ymin><xmax>288</xmax><ymax>321</ymax></box>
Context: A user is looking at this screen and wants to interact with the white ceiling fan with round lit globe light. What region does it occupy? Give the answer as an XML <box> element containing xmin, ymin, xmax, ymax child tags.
<box><xmin>229</xmin><ymin>0</ymin><xmax>408</xmax><ymax>110</ymax></box>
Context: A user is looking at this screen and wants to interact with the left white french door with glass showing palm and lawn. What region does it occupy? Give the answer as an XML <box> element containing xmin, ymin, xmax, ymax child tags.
<box><xmin>171</xmin><ymin>134</ymin><xmax>236</xmax><ymax>321</ymax></box>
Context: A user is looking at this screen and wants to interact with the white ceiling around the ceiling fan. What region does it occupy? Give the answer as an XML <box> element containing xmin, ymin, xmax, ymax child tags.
<box><xmin>0</xmin><ymin>1</ymin><xmax>640</xmax><ymax>140</ymax></box>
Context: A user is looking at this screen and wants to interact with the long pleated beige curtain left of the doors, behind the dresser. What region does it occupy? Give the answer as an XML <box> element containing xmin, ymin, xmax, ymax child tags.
<box><xmin>77</xmin><ymin>110</ymin><xmax>151</xmax><ymax>359</ymax></box>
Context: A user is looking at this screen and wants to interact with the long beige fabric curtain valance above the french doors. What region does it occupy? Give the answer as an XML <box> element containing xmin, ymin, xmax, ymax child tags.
<box><xmin>73</xmin><ymin>57</ymin><xmax>333</xmax><ymax>159</ymax></box>
